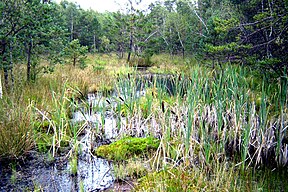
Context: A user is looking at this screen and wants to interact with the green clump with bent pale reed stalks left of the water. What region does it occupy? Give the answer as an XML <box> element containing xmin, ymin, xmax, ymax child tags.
<box><xmin>34</xmin><ymin>84</ymin><xmax>79</xmax><ymax>157</ymax></box>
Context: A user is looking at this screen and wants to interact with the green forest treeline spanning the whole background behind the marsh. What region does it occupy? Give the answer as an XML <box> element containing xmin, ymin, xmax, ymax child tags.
<box><xmin>0</xmin><ymin>0</ymin><xmax>288</xmax><ymax>88</ymax></box>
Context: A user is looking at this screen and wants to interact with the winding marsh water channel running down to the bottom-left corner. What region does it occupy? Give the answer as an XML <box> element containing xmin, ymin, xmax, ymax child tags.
<box><xmin>0</xmin><ymin>75</ymin><xmax>180</xmax><ymax>192</ymax></box>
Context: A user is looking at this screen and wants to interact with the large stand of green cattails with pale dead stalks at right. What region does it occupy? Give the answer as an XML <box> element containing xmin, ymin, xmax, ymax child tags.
<box><xmin>106</xmin><ymin>63</ymin><xmax>288</xmax><ymax>191</ymax></box>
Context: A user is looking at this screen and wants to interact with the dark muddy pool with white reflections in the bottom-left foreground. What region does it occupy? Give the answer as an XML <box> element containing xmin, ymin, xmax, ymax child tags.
<box><xmin>0</xmin><ymin>152</ymin><xmax>114</xmax><ymax>192</ymax></box>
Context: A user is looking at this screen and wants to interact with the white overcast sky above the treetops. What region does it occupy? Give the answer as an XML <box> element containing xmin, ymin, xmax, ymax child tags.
<box><xmin>54</xmin><ymin>0</ymin><xmax>155</xmax><ymax>13</ymax></box>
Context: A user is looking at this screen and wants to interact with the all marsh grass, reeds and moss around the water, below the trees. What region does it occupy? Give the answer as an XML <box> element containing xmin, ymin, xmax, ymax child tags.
<box><xmin>0</xmin><ymin>53</ymin><xmax>288</xmax><ymax>191</ymax></box>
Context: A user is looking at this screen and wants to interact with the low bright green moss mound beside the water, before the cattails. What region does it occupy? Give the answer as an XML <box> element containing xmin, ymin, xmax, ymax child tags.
<box><xmin>95</xmin><ymin>137</ymin><xmax>160</xmax><ymax>161</ymax></box>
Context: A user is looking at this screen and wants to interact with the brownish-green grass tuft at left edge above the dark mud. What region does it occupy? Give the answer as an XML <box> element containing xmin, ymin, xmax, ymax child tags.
<box><xmin>0</xmin><ymin>97</ymin><xmax>35</xmax><ymax>159</ymax></box>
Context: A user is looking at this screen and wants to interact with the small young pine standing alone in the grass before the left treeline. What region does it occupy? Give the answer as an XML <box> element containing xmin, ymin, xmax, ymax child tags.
<box><xmin>64</xmin><ymin>39</ymin><xmax>88</xmax><ymax>67</ymax></box>
